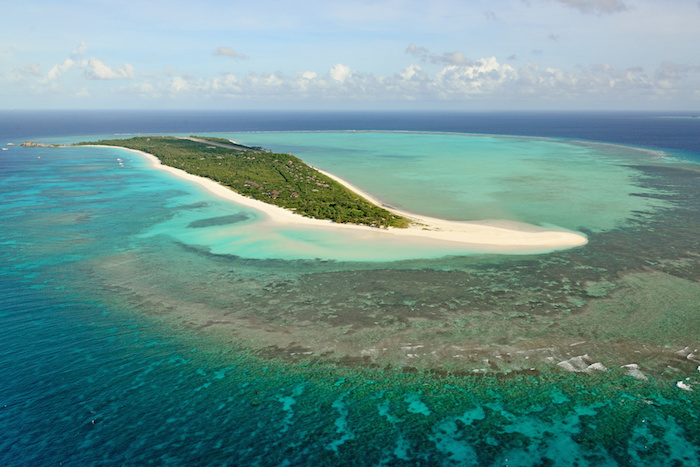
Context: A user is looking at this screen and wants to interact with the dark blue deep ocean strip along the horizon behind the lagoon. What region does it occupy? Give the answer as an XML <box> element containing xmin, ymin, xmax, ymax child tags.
<box><xmin>0</xmin><ymin>110</ymin><xmax>700</xmax><ymax>153</ymax></box>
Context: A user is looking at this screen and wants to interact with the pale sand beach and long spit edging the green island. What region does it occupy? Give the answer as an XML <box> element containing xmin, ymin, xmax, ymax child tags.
<box><xmin>88</xmin><ymin>145</ymin><xmax>588</xmax><ymax>253</ymax></box>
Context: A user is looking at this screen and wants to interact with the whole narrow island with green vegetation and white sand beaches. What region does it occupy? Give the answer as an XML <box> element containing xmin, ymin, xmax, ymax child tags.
<box><xmin>75</xmin><ymin>136</ymin><xmax>588</xmax><ymax>254</ymax></box>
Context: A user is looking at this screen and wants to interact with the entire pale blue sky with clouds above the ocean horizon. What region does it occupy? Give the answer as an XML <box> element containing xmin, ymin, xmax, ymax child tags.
<box><xmin>0</xmin><ymin>0</ymin><xmax>700</xmax><ymax>111</ymax></box>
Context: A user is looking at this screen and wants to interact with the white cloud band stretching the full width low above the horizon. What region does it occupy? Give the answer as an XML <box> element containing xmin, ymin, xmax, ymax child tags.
<box><xmin>6</xmin><ymin>43</ymin><xmax>700</xmax><ymax>107</ymax></box>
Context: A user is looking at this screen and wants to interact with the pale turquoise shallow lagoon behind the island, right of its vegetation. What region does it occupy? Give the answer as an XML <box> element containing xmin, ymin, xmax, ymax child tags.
<box><xmin>226</xmin><ymin>132</ymin><xmax>663</xmax><ymax>232</ymax></box>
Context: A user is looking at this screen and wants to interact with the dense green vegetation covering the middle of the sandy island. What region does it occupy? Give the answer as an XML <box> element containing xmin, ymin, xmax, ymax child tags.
<box><xmin>80</xmin><ymin>136</ymin><xmax>409</xmax><ymax>227</ymax></box>
